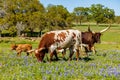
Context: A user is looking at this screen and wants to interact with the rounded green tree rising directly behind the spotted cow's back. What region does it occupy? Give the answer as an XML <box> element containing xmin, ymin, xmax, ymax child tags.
<box><xmin>47</xmin><ymin>5</ymin><xmax>72</xmax><ymax>29</ymax></box>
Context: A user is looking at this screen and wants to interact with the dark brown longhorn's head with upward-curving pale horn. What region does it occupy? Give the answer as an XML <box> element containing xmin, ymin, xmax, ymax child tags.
<box><xmin>88</xmin><ymin>26</ymin><xmax>110</xmax><ymax>43</ymax></box>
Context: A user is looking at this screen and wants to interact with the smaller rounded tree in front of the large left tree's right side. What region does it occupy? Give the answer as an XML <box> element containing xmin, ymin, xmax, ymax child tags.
<box><xmin>27</xmin><ymin>11</ymin><xmax>47</xmax><ymax>35</ymax></box>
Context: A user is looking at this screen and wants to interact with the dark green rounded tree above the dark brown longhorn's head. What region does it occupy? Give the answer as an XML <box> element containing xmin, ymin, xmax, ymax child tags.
<box><xmin>90</xmin><ymin>4</ymin><xmax>115</xmax><ymax>24</ymax></box>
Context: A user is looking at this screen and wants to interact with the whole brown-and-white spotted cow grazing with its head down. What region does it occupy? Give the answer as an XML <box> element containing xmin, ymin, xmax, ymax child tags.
<box><xmin>31</xmin><ymin>30</ymin><xmax>82</xmax><ymax>62</ymax></box>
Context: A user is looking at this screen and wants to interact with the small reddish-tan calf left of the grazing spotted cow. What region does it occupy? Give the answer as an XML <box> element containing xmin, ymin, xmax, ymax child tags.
<box><xmin>11</xmin><ymin>44</ymin><xmax>32</xmax><ymax>56</ymax></box>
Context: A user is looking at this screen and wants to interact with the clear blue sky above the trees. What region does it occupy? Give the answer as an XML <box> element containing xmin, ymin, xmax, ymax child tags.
<box><xmin>40</xmin><ymin>0</ymin><xmax>120</xmax><ymax>16</ymax></box>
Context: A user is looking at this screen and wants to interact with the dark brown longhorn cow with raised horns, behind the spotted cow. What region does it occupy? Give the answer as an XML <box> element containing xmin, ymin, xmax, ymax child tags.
<box><xmin>82</xmin><ymin>26</ymin><xmax>110</xmax><ymax>53</ymax></box>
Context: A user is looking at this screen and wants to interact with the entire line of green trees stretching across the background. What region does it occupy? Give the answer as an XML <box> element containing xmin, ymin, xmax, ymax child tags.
<box><xmin>0</xmin><ymin>0</ymin><xmax>120</xmax><ymax>36</ymax></box>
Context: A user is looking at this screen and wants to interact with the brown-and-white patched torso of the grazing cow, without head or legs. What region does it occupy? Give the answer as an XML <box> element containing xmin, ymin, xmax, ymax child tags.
<box><xmin>38</xmin><ymin>30</ymin><xmax>80</xmax><ymax>48</ymax></box>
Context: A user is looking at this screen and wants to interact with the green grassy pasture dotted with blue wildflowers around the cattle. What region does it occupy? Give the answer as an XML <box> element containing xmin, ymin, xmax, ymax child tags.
<box><xmin>0</xmin><ymin>24</ymin><xmax>120</xmax><ymax>80</ymax></box>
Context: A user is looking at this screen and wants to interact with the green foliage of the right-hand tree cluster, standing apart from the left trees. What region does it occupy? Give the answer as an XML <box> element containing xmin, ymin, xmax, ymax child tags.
<box><xmin>73</xmin><ymin>4</ymin><xmax>115</xmax><ymax>25</ymax></box>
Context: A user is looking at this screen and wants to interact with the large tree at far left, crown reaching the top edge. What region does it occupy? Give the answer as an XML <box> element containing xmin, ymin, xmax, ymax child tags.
<box><xmin>0</xmin><ymin>0</ymin><xmax>45</xmax><ymax>36</ymax></box>
